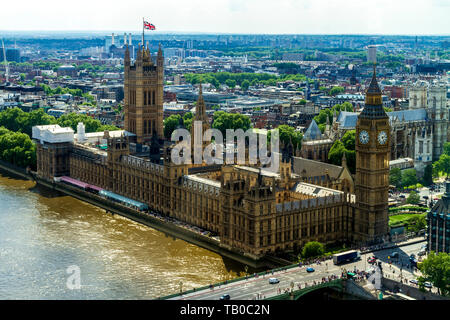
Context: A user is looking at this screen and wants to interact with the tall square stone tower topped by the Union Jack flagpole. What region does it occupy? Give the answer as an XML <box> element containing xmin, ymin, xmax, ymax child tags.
<box><xmin>124</xmin><ymin>45</ymin><xmax>164</xmax><ymax>144</ymax></box>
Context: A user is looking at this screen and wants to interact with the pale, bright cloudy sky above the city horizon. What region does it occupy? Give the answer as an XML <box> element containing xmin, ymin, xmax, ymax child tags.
<box><xmin>0</xmin><ymin>0</ymin><xmax>450</xmax><ymax>35</ymax></box>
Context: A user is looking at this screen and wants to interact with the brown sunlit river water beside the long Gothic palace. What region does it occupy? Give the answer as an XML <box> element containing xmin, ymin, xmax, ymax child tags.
<box><xmin>0</xmin><ymin>171</ymin><xmax>245</xmax><ymax>299</ymax></box>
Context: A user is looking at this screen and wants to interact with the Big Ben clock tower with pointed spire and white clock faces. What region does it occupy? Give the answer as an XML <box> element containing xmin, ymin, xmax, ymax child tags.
<box><xmin>354</xmin><ymin>64</ymin><xmax>390</xmax><ymax>242</ymax></box>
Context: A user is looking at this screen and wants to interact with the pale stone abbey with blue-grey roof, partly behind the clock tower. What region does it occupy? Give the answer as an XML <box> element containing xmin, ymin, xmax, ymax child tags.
<box><xmin>333</xmin><ymin>81</ymin><xmax>450</xmax><ymax>175</ymax></box>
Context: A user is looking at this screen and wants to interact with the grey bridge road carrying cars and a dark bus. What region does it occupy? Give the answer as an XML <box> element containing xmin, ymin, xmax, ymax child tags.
<box><xmin>167</xmin><ymin>241</ymin><xmax>425</xmax><ymax>300</ymax></box>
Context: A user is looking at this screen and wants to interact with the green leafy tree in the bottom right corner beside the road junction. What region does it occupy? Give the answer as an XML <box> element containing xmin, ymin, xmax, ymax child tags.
<box><xmin>418</xmin><ymin>251</ymin><xmax>450</xmax><ymax>296</ymax></box>
